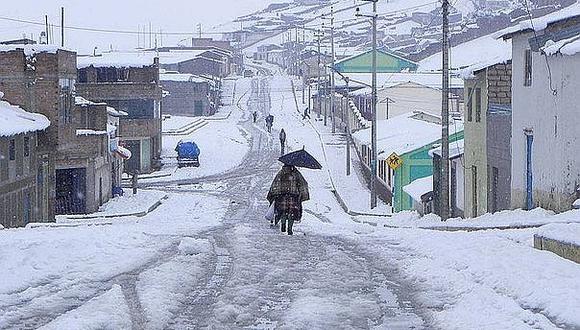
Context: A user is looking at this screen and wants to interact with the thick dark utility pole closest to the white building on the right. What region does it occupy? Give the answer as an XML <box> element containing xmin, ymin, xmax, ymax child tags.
<box><xmin>440</xmin><ymin>0</ymin><xmax>449</xmax><ymax>221</ymax></box>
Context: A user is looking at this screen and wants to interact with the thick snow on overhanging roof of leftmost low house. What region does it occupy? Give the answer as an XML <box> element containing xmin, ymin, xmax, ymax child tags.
<box><xmin>0</xmin><ymin>96</ymin><xmax>50</xmax><ymax>136</ymax></box>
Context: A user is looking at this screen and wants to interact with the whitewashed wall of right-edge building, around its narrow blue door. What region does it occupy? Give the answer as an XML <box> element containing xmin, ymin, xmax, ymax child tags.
<box><xmin>511</xmin><ymin>33</ymin><xmax>580</xmax><ymax>211</ymax></box>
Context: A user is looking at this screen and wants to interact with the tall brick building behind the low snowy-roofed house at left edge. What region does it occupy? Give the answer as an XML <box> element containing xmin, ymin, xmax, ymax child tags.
<box><xmin>0</xmin><ymin>44</ymin><xmax>77</xmax><ymax>221</ymax></box>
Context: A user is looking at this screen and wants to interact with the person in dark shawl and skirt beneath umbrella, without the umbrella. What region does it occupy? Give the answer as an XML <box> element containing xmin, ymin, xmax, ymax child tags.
<box><xmin>268</xmin><ymin>165</ymin><xmax>310</xmax><ymax>235</ymax></box>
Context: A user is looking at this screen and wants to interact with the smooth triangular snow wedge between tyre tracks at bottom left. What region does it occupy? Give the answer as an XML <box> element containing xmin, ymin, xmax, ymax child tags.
<box><xmin>40</xmin><ymin>284</ymin><xmax>131</xmax><ymax>330</ymax></box>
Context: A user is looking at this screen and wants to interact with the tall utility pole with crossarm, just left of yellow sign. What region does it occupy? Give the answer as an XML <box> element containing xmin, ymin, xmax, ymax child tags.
<box><xmin>356</xmin><ymin>0</ymin><xmax>379</xmax><ymax>209</ymax></box>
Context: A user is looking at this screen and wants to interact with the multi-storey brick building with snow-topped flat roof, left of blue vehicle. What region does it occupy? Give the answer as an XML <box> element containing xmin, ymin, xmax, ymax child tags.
<box><xmin>76</xmin><ymin>53</ymin><xmax>162</xmax><ymax>173</ymax></box>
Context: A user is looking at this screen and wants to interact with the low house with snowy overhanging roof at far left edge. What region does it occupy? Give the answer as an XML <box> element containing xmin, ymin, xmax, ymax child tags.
<box><xmin>0</xmin><ymin>92</ymin><xmax>50</xmax><ymax>228</ymax></box>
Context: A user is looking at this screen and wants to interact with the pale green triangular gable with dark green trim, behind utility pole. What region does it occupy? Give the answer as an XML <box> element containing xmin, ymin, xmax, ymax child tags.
<box><xmin>334</xmin><ymin>49</ymin><xmax>417</xmax><ymax>73</ymax></box>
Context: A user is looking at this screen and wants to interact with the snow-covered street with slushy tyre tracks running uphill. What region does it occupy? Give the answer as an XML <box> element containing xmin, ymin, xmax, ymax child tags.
<box><xmin>0</xmin><ymin>73</ymin><xmax>580</xmax><ymax>329</ymax></box>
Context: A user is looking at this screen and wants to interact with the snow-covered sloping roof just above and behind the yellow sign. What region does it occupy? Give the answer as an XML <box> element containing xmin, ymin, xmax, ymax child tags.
<box><xmin>353</xmin><ymin>111</ymin><xmax>463</xmax><ymax>160</ymax></box>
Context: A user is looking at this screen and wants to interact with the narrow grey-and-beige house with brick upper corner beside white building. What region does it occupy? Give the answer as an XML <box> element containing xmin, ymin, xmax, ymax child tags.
<box><xmin>463</xmin><ymin>60</ymin><xmax>512</xmax><ymax>217</ymax></box>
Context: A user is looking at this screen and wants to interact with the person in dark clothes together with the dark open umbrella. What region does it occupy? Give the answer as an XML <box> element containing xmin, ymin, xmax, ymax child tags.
<box><xmin>267</xmin><ymin>149</ymin><xmax>322</xmax><ymax>235</ymax></box>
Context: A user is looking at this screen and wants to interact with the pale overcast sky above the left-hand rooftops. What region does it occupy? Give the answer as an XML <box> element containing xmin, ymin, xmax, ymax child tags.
<box><xmin>0</xmin><ymin>0</ymin><xmax>280</xmax><ymax>53</ymax></box>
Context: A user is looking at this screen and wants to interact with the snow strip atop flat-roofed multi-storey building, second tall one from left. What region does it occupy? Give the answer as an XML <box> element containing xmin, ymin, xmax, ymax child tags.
<box><xmin>77</xmin><ymin>52</ymin><xmax>155</xmax><ymax>69</ymax></box>
